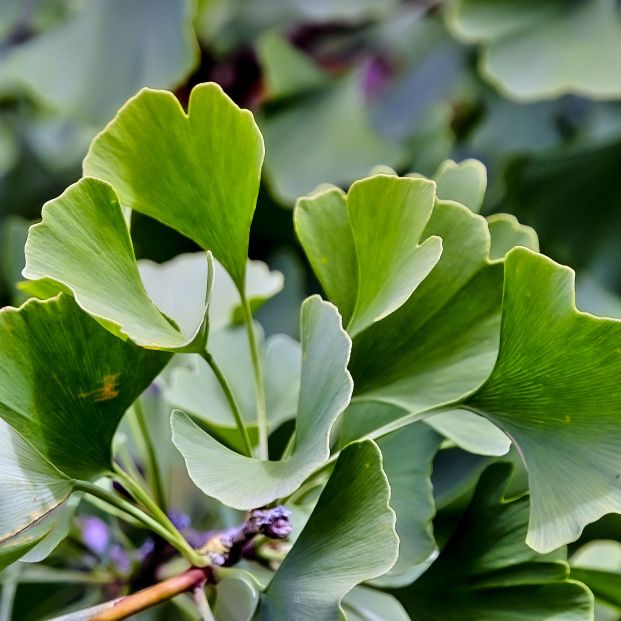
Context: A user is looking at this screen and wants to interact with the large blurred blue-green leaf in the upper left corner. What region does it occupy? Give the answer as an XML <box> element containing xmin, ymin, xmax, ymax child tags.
<box><xmin>0</xmin><ymin>0</ymin><xmax>197</xmax><ymax>125</ymax></box>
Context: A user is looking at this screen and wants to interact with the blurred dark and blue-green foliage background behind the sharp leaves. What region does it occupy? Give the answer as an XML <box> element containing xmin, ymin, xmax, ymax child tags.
<box><xmin>0</xmin><ymin>0</ymin><xmax>621</xmax><ymax>621</ymax></box>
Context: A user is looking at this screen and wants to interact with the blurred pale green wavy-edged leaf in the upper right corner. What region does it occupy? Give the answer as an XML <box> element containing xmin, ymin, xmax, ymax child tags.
<box><xmin>449</xmin><ymin>0</ymin><xmax>621</xmax><ymax>101</ymax></box>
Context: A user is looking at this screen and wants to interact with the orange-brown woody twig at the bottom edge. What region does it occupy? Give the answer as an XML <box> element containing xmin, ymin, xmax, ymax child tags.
<box><xmin>91</xmin><ymin>567</ymin><xmax>215</xmax><ymax>621</ymax></box>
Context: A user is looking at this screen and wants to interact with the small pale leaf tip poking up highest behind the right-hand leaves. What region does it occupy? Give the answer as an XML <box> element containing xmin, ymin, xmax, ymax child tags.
<box><xmin>434</xmin><ymin>159</ymin><xmax>487</xmax><ymax>213</ymax></box>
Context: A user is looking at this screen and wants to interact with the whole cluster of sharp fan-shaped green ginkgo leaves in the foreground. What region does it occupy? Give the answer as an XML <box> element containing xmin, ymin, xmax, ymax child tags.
<box><xmin>0</xmin><ymin>83</ymin><xmax>621</xmax><ymax>621</ymax></box>
